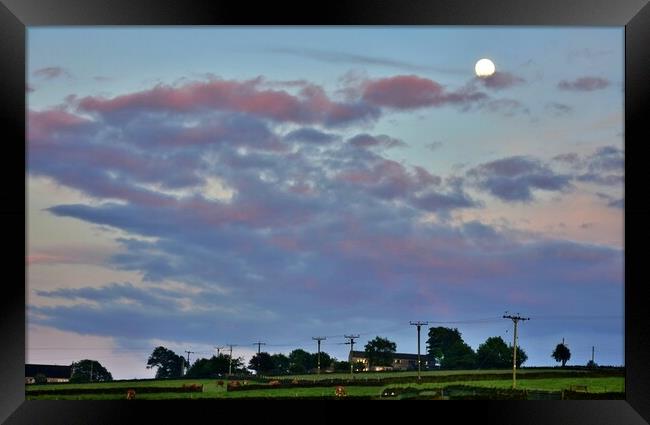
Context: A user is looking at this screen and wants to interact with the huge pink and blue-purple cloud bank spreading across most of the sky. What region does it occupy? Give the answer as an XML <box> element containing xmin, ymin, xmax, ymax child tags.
<box><xmin>27</xmin><ymin>70</ymin><xmax>623</xmax><ymax>368</ymax></box>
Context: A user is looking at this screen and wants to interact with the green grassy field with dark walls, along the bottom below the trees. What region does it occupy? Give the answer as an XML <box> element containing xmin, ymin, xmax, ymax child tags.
<box><xmin>26</xmin><ymin>369</ymin><xmax>625</xmax><ymax>400</ymax></box>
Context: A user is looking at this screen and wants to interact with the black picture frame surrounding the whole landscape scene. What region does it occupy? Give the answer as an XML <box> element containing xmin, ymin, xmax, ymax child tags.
<box><xmin>0</xmin><ymin>0</ymin><xmax>650</xmax><ymax>425</ymax></box>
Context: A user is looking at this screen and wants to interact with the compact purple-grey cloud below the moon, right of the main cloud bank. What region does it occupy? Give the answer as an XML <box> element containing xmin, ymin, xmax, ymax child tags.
<box><xmin>467</xmin><ymin>156</ymin><xmax>571</xmax><ymax>202</ymax></box>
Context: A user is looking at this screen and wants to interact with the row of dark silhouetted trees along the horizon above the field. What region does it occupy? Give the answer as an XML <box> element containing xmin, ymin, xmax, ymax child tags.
<box><xmin>50</xmin><ymin>327</ymin><xmax>576</xmax><ymax>383</ymax></box>
